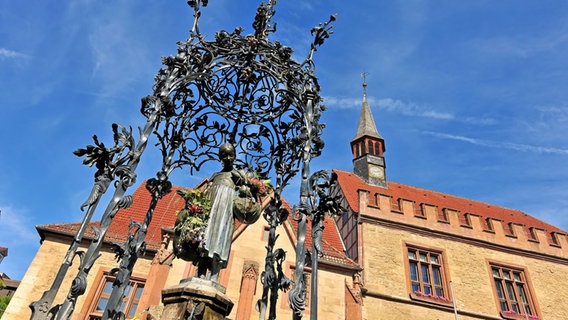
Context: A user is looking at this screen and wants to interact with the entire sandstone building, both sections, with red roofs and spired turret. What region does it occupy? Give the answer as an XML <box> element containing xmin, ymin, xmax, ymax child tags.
<box><xmin>3</xmin><ymin>83</ymin><xmax>568</xmax><ymax>320</ymax></box>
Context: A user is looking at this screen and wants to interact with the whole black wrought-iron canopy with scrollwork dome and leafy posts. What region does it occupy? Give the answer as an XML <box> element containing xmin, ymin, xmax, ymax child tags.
<box><xmin>30</xmin><ymin>0</ymin><xmax>335</xmax><ymax>319</ymax></box>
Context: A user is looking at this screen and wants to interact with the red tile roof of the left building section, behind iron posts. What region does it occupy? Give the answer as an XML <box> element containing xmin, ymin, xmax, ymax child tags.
<box><xmin>37</xmin><ymin>182</ymin><xmax>356</xmax><ymax>266</ymax></box>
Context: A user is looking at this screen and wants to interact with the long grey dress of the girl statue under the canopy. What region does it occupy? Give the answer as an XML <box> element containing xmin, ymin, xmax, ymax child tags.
<box><xmin>204</xmin><ymin>171</ymin><xmax>235</xmax><ymax>268</ymax></box>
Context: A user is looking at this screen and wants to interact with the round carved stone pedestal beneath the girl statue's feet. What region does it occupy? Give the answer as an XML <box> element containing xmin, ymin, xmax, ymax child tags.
<box><xmin>161</xmin><ymin>278</ymin><xmax>233</xmax><ymax>320</ymax></box>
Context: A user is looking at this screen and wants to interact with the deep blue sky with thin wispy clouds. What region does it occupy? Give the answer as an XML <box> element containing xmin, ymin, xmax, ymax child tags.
<box><xmin>0</xmin><ymin>0</ymin><xmax>568</xmax><ymax>279</ymax></box>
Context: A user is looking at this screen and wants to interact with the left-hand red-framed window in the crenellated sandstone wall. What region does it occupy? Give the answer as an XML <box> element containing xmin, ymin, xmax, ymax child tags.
<box><xmin>404</xmin><ymin>242</ymin><xmax>453</xmax><ymax>306</ymax></box>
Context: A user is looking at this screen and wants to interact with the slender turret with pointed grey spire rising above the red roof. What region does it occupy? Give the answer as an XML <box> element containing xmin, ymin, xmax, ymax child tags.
<box><xmin>351</xmin><ymin>74</ymin><xmax>387</xmax><ymax>188</ymax></box>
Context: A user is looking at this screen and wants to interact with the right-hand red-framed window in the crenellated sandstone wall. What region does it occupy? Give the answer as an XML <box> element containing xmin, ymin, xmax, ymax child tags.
<box><xmin>487</xmin><ymin>261</ymin><xmax>542</xmax><ymax>319</ymax></box>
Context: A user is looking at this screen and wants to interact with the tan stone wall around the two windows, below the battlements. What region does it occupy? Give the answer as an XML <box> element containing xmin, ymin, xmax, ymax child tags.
<box><xmin>363</xmin><ymin>216</ymin><xmax>568</xmax><ymax>320</ymax></box>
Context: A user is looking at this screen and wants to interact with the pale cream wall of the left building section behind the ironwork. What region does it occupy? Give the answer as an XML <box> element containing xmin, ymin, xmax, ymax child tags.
<box><xmin>6</xmin><ymin>210</ymin><xmax>353</xmax><ymax>320</ymax></box>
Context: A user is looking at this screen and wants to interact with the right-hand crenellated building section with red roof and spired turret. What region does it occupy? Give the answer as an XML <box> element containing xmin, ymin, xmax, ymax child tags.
<box><xmin>334</xmin><ymin>81</ymin><xmax>568</xmax><ymax>320</ymax></box>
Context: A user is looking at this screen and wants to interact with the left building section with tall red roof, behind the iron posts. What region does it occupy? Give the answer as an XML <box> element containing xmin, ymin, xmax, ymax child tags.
<box><xmin>2</xmin><ymin>182</ymin><xmax>360</xmax><ymax>320</ymax></box>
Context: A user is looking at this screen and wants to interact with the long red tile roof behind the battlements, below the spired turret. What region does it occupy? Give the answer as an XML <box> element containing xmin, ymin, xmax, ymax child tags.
<box><xmin>334</xmin><ymin>170</ymin><xmax>566</xmax><ymax>234</ymax></box>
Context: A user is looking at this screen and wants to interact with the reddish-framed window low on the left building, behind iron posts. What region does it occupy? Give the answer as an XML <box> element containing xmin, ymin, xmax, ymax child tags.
<box><xmin>82</xmin><ymin>268</ymin><xmax>146</xmax><ymax>320</ymax></box>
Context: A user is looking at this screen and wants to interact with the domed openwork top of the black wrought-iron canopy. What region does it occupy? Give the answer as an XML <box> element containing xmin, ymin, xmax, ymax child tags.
<box><xmin>146</xmin><ymin>12</ymin><xmax>323</xmax><ymax>188</ymax></box>
